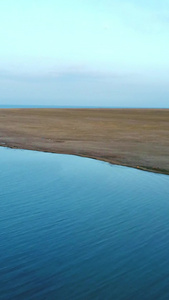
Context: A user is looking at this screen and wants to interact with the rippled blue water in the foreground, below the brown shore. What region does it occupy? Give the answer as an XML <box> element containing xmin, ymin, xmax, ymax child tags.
<box><xmin>0</xmin><ymin>148</ymin><xmax>169</xmax><ymax>300</ymax></box>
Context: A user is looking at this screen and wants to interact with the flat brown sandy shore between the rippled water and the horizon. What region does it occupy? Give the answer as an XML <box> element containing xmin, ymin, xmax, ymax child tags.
<box><xmin>0</xmin><ymin>109</ymin><xmax>169</xmax><ymax>174</ymax></box>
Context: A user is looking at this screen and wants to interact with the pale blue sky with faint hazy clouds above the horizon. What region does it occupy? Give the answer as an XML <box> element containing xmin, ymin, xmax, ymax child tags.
<box><xmin>0</xmin><ymin>0</ymin><xmax>169</xmax><ymax>108</ymax></box>
